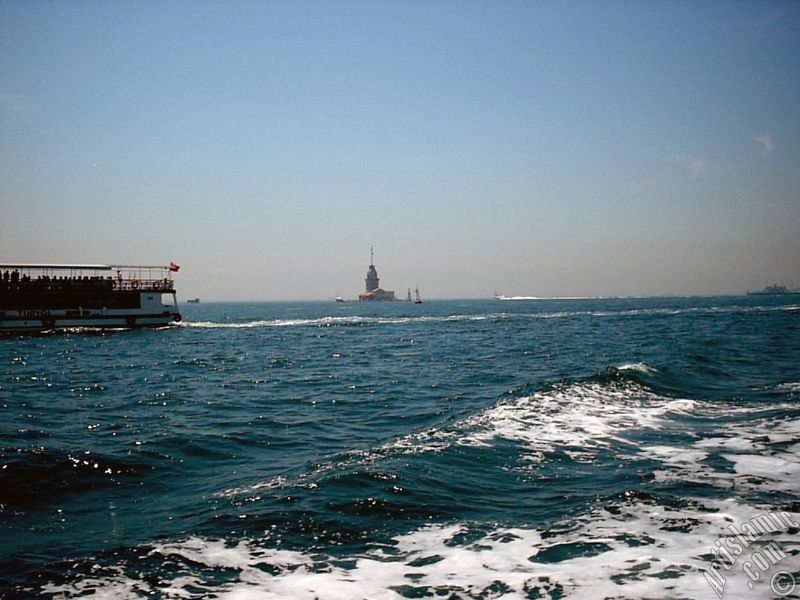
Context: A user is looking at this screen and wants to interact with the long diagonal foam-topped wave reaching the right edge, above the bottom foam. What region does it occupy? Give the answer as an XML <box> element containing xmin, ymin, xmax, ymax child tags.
<box><xmin>218</xmin><ymin>362</ymin><xmax>800</xmax><ymax>504</ymax></box>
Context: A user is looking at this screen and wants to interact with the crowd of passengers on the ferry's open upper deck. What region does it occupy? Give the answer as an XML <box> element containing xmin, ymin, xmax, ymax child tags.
<box><xmin>0</xmin><ymin>269</ymin><xmax>173</xmax><ymax>291</ymax></box>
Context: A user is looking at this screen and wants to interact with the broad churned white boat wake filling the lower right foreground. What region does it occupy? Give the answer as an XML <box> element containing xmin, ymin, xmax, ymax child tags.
<box><xmin>20</xmin><ymin>363</ymin><xmax>800</xmax><ymax>600</ymax></box>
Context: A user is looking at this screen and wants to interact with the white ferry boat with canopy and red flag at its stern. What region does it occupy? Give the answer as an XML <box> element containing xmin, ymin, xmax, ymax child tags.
<box><xmin>0</xmin><ymin>263</ymin><xmax>181</xmax><ymax>332</ymax></box>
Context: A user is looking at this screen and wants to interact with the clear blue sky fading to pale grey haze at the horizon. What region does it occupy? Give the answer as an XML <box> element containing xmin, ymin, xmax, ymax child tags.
<box><xmin>0</xmin><ymin>0</ymin><xmax>800</xmax><ymax>301</ymax></box>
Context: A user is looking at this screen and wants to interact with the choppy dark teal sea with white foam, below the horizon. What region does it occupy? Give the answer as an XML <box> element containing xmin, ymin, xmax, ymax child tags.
<box><xmin>0</xmin><ymin>296</ymin><xmax>800</xmax><ymax>600</ymax></box>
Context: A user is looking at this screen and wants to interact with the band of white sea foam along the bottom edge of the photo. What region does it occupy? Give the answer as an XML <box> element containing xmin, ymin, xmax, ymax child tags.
<box><xmin>45</xmin><ymin>500</ymin><xmax>800</xmax><ymax>600</ymax></box>
